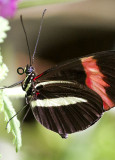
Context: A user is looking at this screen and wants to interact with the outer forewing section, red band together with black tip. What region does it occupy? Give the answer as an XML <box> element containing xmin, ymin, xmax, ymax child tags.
<box><xmin>81</xmin><ymin>51</ymin><xmax>115</xmax><ymax>111</ymax></box>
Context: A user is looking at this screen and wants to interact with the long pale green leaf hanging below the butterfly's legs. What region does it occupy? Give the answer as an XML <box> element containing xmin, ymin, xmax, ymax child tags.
<box><xmin>0</xmin><ymin>94</ymin><xmax>22</xmax><ymax>152</ymax></box>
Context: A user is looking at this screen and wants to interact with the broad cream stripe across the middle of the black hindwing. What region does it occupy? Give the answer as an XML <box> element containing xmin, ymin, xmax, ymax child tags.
<box><xmin>31</xmin><ymin>97</ymin><xmax>87</xmax><ymax>108</ymax></box>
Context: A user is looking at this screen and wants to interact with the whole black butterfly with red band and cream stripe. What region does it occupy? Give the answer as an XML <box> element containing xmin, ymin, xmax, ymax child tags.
<box><xmin>3</xmin><ymin>10</ymin><xmax>115</xmax><ymax>138</ymax></box>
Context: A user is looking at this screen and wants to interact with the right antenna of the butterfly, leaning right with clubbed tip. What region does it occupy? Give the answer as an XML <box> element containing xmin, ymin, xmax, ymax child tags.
<box><xmin>32</xmin><ymin>9</ymin><xmax>47</xmax><ymax>64</ymax></box>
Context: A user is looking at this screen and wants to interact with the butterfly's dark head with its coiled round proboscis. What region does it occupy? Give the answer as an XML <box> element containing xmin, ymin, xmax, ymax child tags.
<box><xmin>17</xmin><ymin>64</ymin><xmax>34</xmax><ymax>75</ymax></box>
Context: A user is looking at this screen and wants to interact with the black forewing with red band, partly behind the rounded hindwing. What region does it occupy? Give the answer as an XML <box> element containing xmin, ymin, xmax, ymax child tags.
<box><xmin>35</xmin><ymin>51</ymin><xmax>115</xmax><ymax>111</ymax></box>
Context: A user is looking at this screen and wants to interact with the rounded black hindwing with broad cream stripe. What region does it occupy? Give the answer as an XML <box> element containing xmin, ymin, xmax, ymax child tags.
<box><xmin>31</xmin><ymin>81</ymin><xmax>103</xmax><ymax>138</ymax></box>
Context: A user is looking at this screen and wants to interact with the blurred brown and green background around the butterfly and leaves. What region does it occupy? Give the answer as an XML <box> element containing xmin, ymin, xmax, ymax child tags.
<box><xmin>0</xmin><ymin>0</ymin><xmax>115</xmax><ymax>160</ymax></box>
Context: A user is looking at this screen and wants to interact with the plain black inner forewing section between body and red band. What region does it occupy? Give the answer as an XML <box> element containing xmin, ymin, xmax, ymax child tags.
<box><xmin>35</xmin><ymin>54</ymin><xmax>86</xmax><ymax>85</ymax></box>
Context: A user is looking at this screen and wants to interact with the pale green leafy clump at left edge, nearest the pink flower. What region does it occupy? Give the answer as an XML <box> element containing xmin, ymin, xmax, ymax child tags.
<box><xmin>0</xmin><ymin>17</ymin><xmax>10</xmax><ymax>43</ymax></box>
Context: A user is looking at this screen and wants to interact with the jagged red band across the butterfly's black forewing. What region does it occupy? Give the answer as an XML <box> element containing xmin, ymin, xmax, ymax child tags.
<box><xmin>81</xmin><ymin>56</ymin><xmax>114</xmax><ymax>110</ymax></box>
